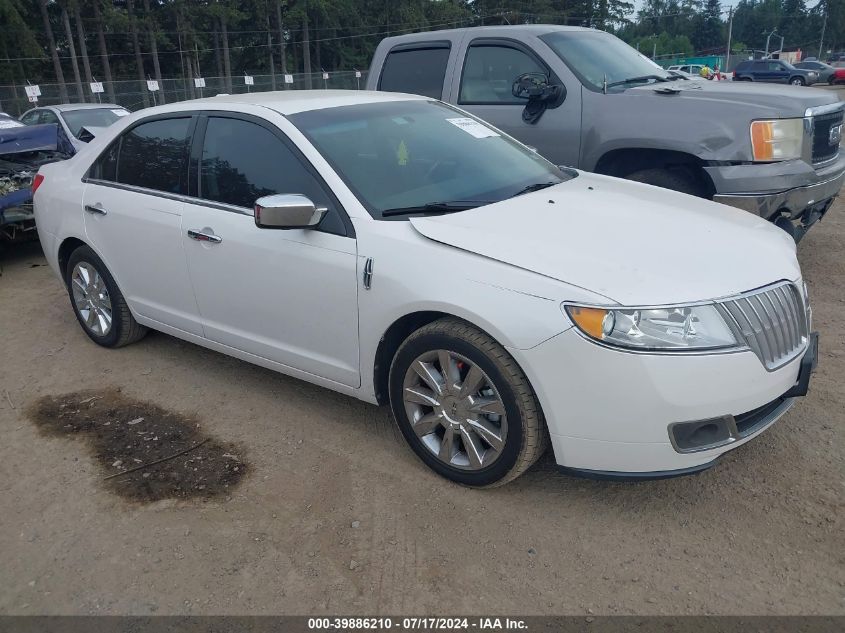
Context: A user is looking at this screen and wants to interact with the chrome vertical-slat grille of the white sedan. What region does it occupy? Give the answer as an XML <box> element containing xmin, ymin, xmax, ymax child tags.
<box><xmin>717</xmin><ymin>282</ymin><xmax>808</xmax><ymax>370</ymax></box>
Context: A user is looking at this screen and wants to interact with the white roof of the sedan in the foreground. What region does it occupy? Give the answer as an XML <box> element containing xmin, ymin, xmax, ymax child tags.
<box><xmin>143</xmin><ymin>90</ymin><xmax>431</xmax><ymax>115</ymax></box>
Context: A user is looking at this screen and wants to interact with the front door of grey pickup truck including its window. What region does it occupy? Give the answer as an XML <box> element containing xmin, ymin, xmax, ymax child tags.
<box><xmin>452</xmin><ymin>38</ymin><xmax>581</xmax><ymax>166</ymax></box>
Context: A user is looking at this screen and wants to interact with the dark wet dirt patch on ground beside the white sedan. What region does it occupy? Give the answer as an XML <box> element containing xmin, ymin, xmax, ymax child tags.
<box><xmin>28</xmin><ymin>389</ymin><xmax>247</xmax><ymax>502</ymax></box>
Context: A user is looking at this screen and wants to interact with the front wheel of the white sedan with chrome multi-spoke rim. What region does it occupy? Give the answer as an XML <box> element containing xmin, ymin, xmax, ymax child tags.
<box><xmin>389</xmin><ymin>318</ymin><xmax>548</xmax><ymax>487</ymax></box>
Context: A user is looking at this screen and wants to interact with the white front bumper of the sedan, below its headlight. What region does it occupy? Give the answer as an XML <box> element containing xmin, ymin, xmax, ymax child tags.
<box><xmin>514</xmin><ymin>329</ymin><xmax>815</xmax><ymax>479</ymax></box>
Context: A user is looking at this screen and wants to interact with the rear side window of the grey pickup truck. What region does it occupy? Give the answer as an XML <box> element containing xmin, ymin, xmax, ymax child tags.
<box><xmin>379</xmin><ymin>46</ymin><xmax>449</xmax><ymax>99</ymax></box>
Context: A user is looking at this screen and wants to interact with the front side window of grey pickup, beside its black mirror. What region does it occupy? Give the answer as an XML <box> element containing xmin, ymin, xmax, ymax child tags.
<box><xmin>458</xmin><ymin>44</ymin><xmax>547</xmax><ymax>105</ymax></box>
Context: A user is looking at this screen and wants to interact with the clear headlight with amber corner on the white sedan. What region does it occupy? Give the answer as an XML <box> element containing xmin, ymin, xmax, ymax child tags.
<box><xmin>564</xmin><ymin>305</ymin><xmax>737</xmax><ymax>351</ymax></box>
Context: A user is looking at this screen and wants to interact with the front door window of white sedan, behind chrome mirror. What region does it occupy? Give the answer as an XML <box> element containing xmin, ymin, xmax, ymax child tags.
<box><xmin>199</xmin><ymin>117</ymin><xmax>345</xmax><ymax>234</ymax></box>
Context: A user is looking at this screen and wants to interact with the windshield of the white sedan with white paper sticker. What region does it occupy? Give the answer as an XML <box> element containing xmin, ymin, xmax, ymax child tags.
<box><xmin>289</xmin><ymin>101</ymin><xmax>572</xmax><ymax>219</ymax></box>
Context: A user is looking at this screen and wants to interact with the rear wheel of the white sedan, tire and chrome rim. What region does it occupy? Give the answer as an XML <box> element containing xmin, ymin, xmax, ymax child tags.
<box><xmin>65</xmin><ymin>246</ymin><xmax>147</xmax><ymax>347</ymax></box>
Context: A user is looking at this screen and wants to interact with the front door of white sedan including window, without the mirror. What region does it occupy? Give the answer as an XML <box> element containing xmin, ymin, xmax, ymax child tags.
<box><xmin>182</xmin><ymin>115</ymin><xmax>360</xmax><ymax>387</ymax></box>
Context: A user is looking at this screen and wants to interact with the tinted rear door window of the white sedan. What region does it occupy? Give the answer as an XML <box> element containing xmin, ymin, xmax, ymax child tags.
<box><xmin>116</xmin><ymin>117</ymin><xmax>191</xmax><ymax>193</ymax></box>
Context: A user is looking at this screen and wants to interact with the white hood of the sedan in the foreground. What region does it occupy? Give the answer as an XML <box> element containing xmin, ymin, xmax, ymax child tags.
<box><xmin>410</xmin><ymin>172</ymin><xmax>801</xmax><ymax>305</ymax></box>
